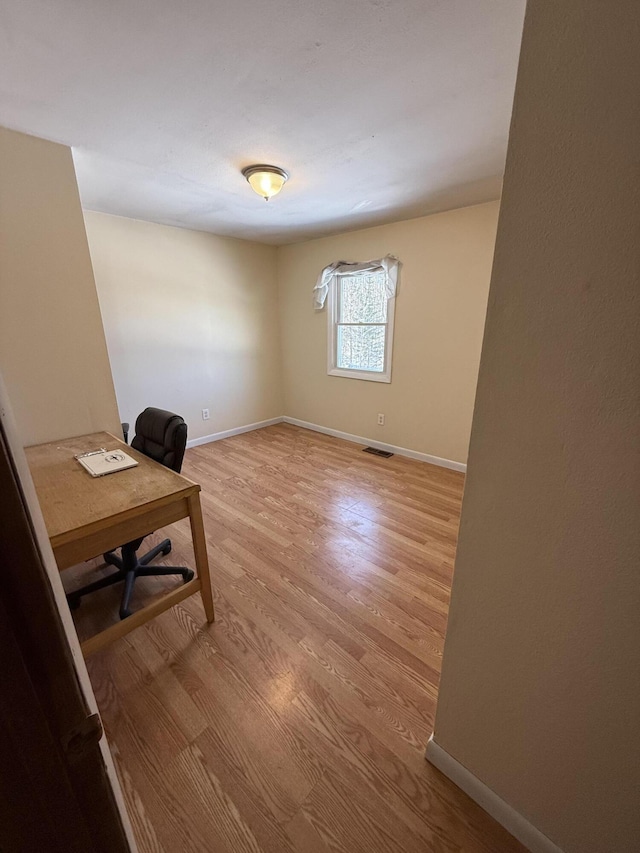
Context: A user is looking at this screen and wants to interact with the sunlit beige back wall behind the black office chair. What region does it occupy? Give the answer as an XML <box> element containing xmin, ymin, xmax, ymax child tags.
<box><xmin>85</xmin><ymin>212</ymin><xmax>282</xmax><ymax>439</ymax></box>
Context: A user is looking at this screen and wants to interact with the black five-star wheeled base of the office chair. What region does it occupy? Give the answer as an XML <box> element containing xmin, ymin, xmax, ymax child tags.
<box><xmin>67</xmin><ymin>539</ymin><xmax>194</xmax><ymax>619</ymax></box>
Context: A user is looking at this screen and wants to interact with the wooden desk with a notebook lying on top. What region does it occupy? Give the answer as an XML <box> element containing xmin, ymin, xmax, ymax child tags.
<box><xmin>25</xmin><ymin>432</ymin><xmax>214</xmax><ymax>657</ymax></box>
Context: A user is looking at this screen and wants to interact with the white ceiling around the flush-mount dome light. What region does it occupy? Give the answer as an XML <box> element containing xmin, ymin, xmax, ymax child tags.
<box><xmin>0</xmin><ymin>0</ymin><xmax>525</xmax><ymax>243</ymax></box>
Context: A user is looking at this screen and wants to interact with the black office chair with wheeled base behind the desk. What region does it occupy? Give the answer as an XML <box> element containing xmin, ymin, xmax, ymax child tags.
<box><xmin>67</xmin><ymin>408</ymin><xmax>193</xmax><ymax>619</ymax></box>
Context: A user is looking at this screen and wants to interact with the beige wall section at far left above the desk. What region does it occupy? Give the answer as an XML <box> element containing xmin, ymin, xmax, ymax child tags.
<box><xmin>0</xmin><ymin>128</ymin><xmax>119</xmax><ymax>445</ymax></box>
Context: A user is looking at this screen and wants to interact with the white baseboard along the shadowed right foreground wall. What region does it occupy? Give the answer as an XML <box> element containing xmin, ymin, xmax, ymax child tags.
<box><xmin>426</xmin><ymin>735</ymin><xmax>562</xmax><ymax>853</ymax></box>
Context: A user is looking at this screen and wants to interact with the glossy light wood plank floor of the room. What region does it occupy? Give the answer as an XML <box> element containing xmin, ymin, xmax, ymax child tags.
<box><xmin>72</xmin><ymin>425</ymin><xmax>523</xmax><ymax>853</ymax></box>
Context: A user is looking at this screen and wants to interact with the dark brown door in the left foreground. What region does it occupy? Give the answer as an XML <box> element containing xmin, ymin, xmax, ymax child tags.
<box><xmin>0</xmin><ymin>402</ymin><xmax>133</xmax><ymax>853</ymax></box>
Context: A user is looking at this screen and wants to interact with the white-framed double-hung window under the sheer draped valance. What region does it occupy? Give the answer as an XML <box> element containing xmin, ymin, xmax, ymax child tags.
<box><xmin>328</xmin><ymin>270</ymin><xmax>395</xmax><ymax>382</ymax></box>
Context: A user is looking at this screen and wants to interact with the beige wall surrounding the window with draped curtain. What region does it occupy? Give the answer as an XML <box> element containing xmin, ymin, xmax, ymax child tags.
<box><xmin>278</xmin><ymin>202</ymin><xmax>498</xmax><ymax>462</ymax></box>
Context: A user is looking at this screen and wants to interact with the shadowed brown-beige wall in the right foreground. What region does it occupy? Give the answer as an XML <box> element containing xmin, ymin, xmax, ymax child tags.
<box><xmin>434</xmin><ymin>0</ymin><xmax>640</xmax><ymax>853</ymax></box>
